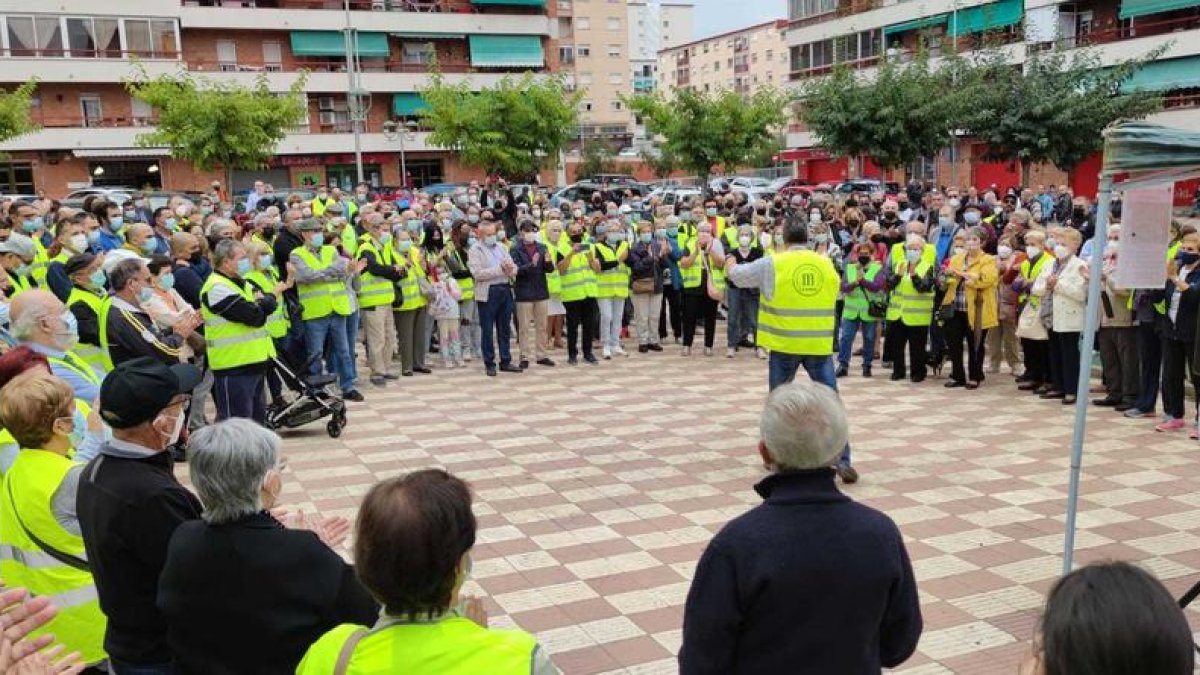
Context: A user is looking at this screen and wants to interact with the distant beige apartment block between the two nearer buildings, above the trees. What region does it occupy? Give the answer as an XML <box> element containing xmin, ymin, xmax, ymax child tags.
<box><xmin>658</xmin><ymin>19</ymin><xmax>788</xmax><ymax>94</ymax></box>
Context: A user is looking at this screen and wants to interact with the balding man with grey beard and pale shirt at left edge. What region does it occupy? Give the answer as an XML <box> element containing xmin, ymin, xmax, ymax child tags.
<box><xmin>10</xmin><ymin>288</ymin><xmax>104</xmax><ymax>402</ymax></box>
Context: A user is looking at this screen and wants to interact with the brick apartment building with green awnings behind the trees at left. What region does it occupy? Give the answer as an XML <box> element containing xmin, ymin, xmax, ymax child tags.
<box><xmin>0</xmin><ymin>0</ymin><xmax>554</xmax><ymax>195</ymax></box>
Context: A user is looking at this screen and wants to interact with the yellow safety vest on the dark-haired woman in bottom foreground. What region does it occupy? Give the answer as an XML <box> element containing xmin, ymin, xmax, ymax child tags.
<box><xmin>296</xmin><ymin>616</ymin><xmax>538</xmax><ymax>675</ymax></box>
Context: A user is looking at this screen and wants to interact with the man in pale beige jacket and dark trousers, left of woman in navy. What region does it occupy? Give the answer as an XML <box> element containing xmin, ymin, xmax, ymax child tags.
<box><xmin>467</xmin><ymin>222</ymin><xmax>521</xmax><ymax>377</ymax></box>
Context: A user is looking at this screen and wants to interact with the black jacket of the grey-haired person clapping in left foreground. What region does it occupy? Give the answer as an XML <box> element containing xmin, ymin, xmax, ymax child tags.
<box><xmin>158</xmin><ymin>513</ymin><xmax>379</xmax><ymax>675</ymax></box>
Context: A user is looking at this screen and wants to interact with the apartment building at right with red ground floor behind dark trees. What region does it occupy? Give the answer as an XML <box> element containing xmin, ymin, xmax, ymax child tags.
<box><xmin>784</xmin><ymin>0</ymin><xmax>1200</xmax><ymax>196</ymax></box>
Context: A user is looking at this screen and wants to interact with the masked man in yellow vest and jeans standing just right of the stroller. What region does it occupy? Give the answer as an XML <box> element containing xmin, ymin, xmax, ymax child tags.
<box><xmin>289</xmin><ymin>219</ymin><xmax>366</xmax><ymax>401</ymax></box>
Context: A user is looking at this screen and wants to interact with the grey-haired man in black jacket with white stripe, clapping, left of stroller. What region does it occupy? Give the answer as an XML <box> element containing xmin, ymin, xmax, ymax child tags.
<box><xmin>100</xmin><ymin>258</ymin><xmax>200</xmax><ymax>365</ymax></box>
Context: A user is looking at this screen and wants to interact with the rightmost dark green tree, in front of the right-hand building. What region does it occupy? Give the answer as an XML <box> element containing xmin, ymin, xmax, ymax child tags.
<box><xmin>959</xmin><ymin>46</ymin><xmax>1166</xmax><ymax>185</ymax></box>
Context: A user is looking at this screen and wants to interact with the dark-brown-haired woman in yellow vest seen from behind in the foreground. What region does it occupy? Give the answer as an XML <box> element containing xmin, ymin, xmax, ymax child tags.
<box><xmin>296</xmin><ymin>468</ymin><xmax>558</xmax><ymax>675</ymax></box>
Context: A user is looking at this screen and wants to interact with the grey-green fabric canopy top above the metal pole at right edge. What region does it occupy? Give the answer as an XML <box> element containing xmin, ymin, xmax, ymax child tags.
<box><xmin>1103</xmin><ymin>121</ymin><xmax>1200</xmax><ymax>175</ymax></box>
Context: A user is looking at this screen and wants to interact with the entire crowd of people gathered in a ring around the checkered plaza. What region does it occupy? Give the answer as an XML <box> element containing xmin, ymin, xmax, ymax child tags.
<box><xmin>0</xmin><ymin>180</ymin><xmax>1200</xmax><ymax>675</ymax></box>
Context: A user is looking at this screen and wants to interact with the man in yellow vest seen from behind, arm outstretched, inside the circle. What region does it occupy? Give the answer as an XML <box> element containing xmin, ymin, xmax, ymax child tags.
<box><xmin>725</xmin><ymin>222</ymin><xmax>858</xmax><ymax>483</ymax></box>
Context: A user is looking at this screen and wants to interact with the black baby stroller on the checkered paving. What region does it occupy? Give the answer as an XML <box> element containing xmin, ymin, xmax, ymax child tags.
<box><xmin>266</xmin><ymin>345</ymin><xmax>346</xmax><ymax>438</ymax></box>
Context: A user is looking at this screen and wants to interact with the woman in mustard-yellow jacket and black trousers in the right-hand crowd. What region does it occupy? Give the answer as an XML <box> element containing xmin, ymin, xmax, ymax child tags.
<box><xmin>941</xmin><ymin>227</ymin><xmax>1000</xmax><ymax>389</ymax></box>
